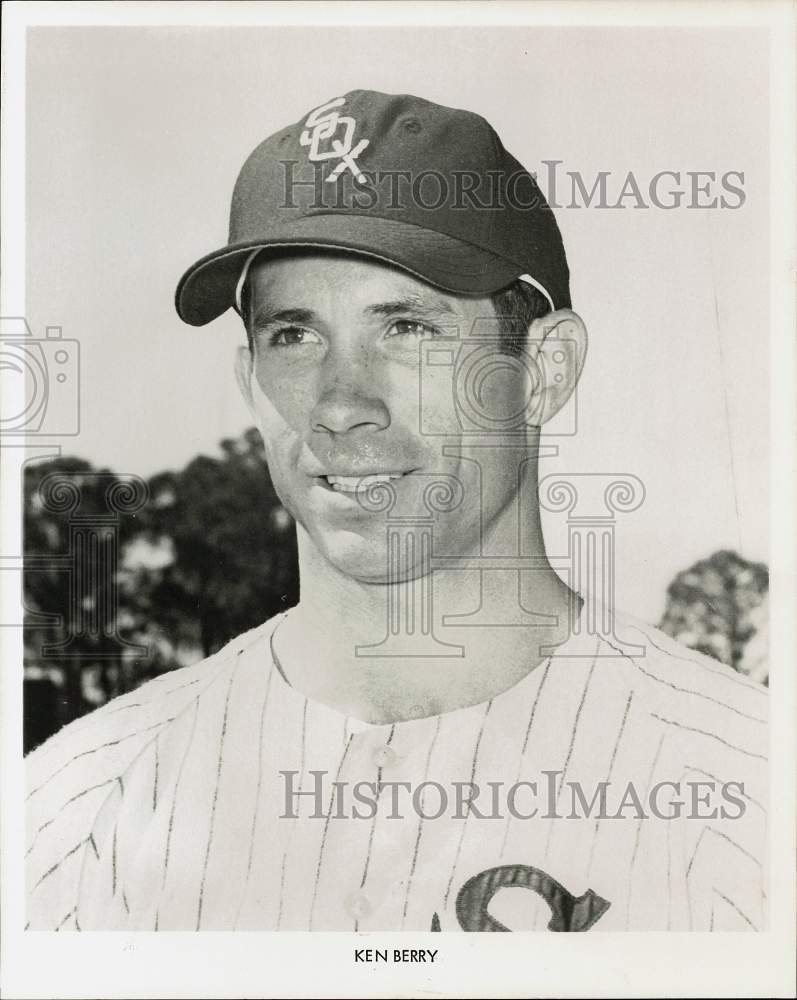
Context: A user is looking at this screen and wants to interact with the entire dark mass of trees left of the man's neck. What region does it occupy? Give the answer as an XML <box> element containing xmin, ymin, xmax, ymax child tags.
<box><xmin>23</xmin><ymin>429</ymin><xmax>298</xmax><ymax>750</ymax></box>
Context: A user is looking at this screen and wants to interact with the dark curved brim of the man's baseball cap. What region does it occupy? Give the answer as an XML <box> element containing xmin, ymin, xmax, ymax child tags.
<box><xmin>175</xmin><ymin>213</ymin><xmax>522</xmax><ymax>326</ymax></box>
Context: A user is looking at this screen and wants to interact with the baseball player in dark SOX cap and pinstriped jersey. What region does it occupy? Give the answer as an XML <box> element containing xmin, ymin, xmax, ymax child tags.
<box><xmin>26</xmin><ymin>91</ymin><xmax>767</xmax><ymax>932</ymax></box>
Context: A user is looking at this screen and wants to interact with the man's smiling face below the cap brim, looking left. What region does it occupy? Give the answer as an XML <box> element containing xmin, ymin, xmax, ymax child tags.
<box><xmin>236</xmin><ymin>254</ymin><xmax>528</xmax><ymax>582</ymax></box>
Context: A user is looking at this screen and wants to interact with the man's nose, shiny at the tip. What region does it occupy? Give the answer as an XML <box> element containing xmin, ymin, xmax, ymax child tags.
<box><xmin>310</xmin><ymin>354</ymin><xmax>390</xmax><ymax>434</ymax></box>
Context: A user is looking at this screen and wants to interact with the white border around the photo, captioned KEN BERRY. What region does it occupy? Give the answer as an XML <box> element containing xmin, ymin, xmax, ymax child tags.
<box><xmin>0</xmin><ymin>0</ymin><xmax>797</xmax><ymax>998</ymax></box>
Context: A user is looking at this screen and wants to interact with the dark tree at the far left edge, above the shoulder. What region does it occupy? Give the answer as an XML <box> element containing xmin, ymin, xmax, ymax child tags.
<box><xmin>23</xmin><ymin>458</ymin><xmax>151</xmax><ymax>743</ymax></box>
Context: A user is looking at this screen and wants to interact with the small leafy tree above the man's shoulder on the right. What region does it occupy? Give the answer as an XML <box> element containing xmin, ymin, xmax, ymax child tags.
<box><xmin>659</xmin><ymin>549</ymin><xmax>769</xmax><ymax>684</ymax></box>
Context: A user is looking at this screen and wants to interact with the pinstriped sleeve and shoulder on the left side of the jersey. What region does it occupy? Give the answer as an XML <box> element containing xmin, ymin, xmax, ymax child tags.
<box><xmin>25</xmin><ymin>619</ymin><xmax>275</xmax><ymax>929</ymax></box>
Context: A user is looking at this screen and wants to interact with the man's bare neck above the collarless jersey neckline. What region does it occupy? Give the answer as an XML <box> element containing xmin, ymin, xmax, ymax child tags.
<box><xmin>275</xmin><ymin>462</ymin><xmax>575</xmax><ymax>721</ymax></box>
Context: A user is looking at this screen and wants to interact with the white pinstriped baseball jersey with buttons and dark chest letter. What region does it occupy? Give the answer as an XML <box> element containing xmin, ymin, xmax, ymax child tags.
<box><xmin>26</xmin><ymin>614</ymin><xmax>767</xmax><ymax>931</ymax></box>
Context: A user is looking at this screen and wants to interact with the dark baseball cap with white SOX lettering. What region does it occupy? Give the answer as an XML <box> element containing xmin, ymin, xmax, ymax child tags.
<box><xmin>176</xmin><ymin>90</ymin><xmax>570</xmax><ymax>326</ymax></box>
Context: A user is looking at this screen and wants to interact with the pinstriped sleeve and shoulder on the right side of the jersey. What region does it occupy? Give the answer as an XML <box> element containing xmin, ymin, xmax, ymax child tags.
<box><xmin>600</xmin><ymin>615</ymin><xmax>769</xmax><ymax>930</ymax></box>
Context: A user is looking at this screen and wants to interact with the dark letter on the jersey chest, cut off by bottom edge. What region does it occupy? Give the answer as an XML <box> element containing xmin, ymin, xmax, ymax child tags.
<box><xmin>431</xmin><ymin>865</ymin><xmax>611</xmax><ymax>931</ymax></box>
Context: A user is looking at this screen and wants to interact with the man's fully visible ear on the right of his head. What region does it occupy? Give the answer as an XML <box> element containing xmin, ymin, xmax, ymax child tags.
<box><xmin>528</xmin><ymin>309</ymin><xmax>587</xmax><ymax>426</ymax></box>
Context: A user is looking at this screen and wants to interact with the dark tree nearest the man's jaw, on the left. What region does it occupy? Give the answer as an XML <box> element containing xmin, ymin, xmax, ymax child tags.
<box><xmin>137</xmin><ymin>428</ymin><xmax>299</xmax><ymax>659</ymax></box>
